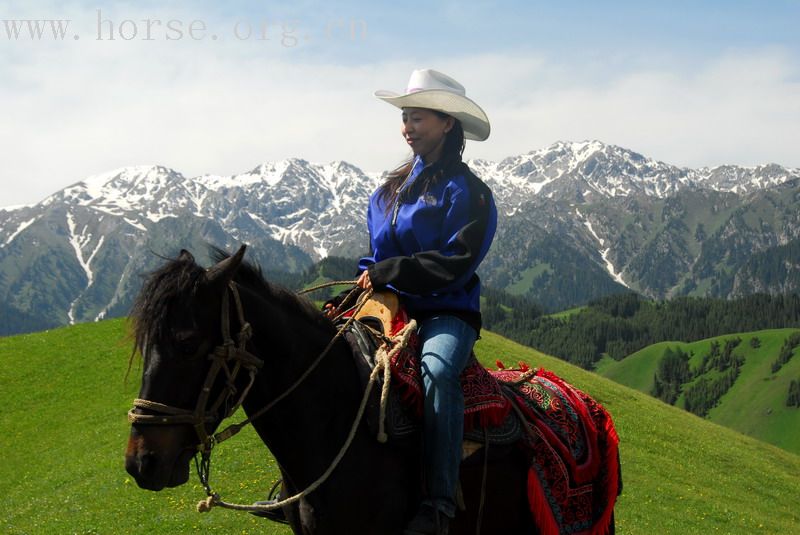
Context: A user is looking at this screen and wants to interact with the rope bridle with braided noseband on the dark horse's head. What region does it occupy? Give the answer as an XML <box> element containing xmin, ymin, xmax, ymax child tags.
<box><xmin>128</xmin><ymin>281</ymin><xmax>264</xmax><ymax>451</ymax></box>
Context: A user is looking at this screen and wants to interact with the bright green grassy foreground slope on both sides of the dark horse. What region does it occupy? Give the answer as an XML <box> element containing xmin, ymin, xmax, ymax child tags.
<box><xmin>0</xmin><ymin>320</ymin><xmax>800</xmax><ymax>535</ymax></box>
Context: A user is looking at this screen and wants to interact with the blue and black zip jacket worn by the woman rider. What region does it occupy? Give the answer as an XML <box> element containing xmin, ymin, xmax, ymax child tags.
<box><xmin>358</xmin><ymin>156</ymin><xmax>497</xmax><ymax>331</ymax></box>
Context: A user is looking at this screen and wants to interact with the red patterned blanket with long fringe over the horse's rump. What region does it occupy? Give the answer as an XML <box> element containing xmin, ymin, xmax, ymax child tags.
<box><xmin>492</xmin><ymin>369</ymin><xmax>622</xmax><ymax>535</ymax></box>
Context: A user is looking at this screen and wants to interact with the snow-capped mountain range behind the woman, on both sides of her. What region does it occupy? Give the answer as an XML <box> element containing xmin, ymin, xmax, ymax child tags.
<box><xmin>0</xmin><ymin>141</ymin><xmax>800</xmax><ymax>334</ymax></box>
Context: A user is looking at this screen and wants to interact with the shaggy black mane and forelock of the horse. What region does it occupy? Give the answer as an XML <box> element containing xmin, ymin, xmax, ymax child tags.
<box><xmin>129</xmin><ymin>246</ymin><xmax>334</xmax><ymax>355</ymax></box>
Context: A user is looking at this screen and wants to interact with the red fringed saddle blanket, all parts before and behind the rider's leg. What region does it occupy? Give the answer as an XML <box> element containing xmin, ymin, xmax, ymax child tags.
<box><xmin>384</xmin><ymin>312</ymin><xmax>621</xmax><ymax>535</ymax></box>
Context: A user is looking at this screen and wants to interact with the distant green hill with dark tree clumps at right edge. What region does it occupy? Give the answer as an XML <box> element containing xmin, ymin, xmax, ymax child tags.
<box><xmin>595</xmin><ymin>328</ymin><xmax>800</xmax><ymax>453</ymax></box>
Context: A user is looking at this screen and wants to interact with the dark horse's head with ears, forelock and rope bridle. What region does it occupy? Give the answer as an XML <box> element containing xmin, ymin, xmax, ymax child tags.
<box><xmin>125</xmin><ymin>246</ymin><xmax>259</xmax><ymax>490</ymax></box>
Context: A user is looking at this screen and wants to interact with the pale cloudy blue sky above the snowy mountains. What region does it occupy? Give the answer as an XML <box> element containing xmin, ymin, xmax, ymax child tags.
<box><xmin>0</xmin><ymin>0</ymin><xmax>800</xmax><ymax>206</ymax></box>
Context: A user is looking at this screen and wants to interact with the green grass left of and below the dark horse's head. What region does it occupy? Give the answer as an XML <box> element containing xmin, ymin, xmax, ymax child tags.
<box><xmin>0</xmin><ymin>320</ymin><xmax>291</xmax><ymax>534</ymax></box>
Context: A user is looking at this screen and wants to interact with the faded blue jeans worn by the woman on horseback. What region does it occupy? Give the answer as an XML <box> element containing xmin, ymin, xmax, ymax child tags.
<box><xmin>419</xmin><ymin>315</ymin><xmax>478</xmax><ymax>518</ymax></box>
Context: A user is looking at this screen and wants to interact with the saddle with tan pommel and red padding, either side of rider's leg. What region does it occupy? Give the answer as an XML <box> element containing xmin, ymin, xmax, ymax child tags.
<box><xmin>344</xmin><ymin>292</ymin><xmax>523</xmax><ymax>457</ymax></box>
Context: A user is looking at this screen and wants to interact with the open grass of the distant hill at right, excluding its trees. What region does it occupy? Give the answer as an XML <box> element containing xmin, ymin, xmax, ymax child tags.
<box><xmin>597</xmin><ymin>329</ymin><xmax>800</xmax><ymax>454</ymax></box>
